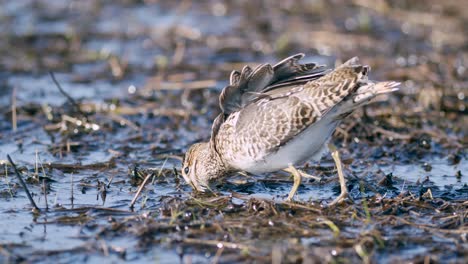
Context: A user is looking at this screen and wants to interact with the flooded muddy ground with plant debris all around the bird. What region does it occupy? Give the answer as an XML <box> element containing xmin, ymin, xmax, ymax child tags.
<box><xmin>0</xmin><ymin>0</ymin><xmax>468</xmax><ymax>263</ymax></box>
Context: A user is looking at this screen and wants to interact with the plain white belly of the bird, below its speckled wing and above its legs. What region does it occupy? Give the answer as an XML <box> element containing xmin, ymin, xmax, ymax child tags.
<box><xmin>235</xmin><ymin>120</ymin><xmax>338</xmax><ymax>173</ymax></box>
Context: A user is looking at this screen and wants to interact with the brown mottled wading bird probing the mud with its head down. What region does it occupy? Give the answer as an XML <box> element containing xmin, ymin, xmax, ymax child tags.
<box><xmin>181</xmin><ymin>53</ymin><xmax>399</xmax><ymax>205</ymax></box>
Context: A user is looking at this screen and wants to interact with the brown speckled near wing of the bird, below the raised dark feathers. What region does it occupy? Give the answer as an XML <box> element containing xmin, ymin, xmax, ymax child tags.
<box><xmin>220</xmin><ymin>58</ymin><xmax>369</xmax><ymax>157</ymax></box>
